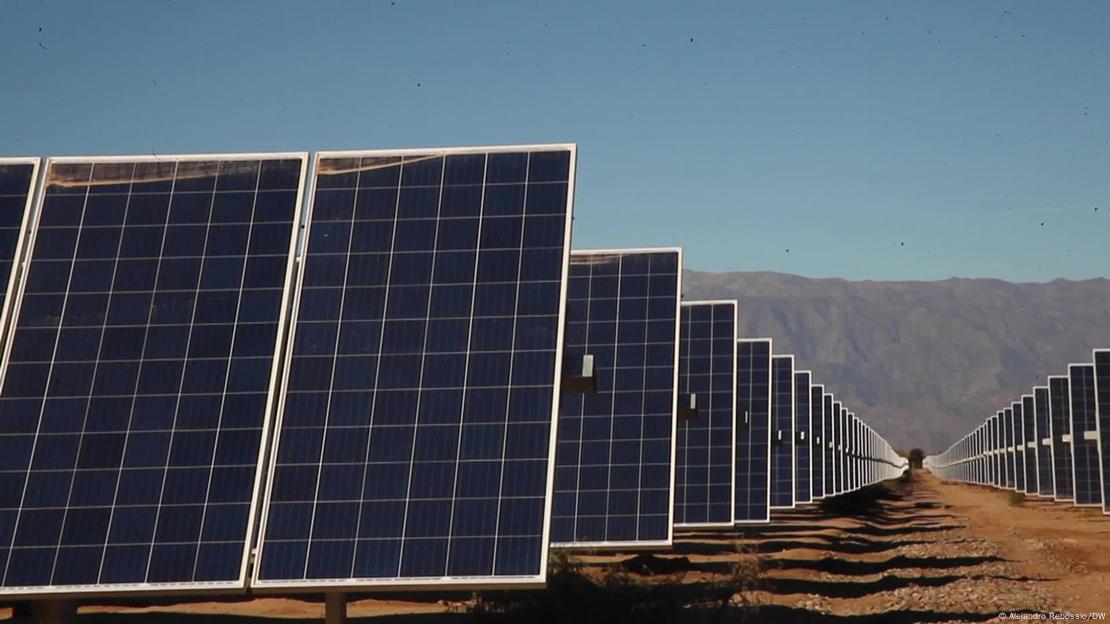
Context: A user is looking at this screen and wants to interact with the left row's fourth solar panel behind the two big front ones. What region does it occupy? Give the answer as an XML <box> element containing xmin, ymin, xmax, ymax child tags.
<box><xmin>770</xmin><ymin>355</ymin><xmax>796</xmax><ymax>509</ymax></box>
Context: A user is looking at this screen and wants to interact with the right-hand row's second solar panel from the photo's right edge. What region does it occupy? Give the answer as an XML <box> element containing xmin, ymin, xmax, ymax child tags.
<box><xmin>1068</xmin><ymin>364</ymin><xmax>1102</xmax><ymax>506</ymax></box>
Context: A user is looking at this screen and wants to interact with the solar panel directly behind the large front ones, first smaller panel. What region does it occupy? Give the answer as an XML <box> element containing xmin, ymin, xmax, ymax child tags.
<box><xmin>552</xmin><ymin>249</ymin><xmax>682</xmax><ymax>546</ymax></box>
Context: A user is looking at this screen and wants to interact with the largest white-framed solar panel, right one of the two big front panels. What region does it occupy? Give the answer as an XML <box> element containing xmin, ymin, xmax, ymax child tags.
<box><xmin>252</xmin><ymin>145</ymin><xmax>575</xmax><ymax>590</ymax></box>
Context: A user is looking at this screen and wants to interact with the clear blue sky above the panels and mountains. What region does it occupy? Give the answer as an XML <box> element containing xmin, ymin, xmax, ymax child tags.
<box><xmin>0</xmin><ymin>0</ymin><xmax>1110</xmax><ymax>281</ymax></box>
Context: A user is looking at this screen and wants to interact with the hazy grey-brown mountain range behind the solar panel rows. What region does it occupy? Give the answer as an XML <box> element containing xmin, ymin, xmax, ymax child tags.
<box><xmin>683</xmin><ymin>271</ymin><xmax>1110</xmax><ymax>453</ymax></box>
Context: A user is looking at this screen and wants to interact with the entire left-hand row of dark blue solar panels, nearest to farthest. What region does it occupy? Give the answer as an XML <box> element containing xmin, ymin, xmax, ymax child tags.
<box><xmin>0</xmin><ymin>145</ymin><xmax>898</xmax><ymax>595</ymax></box>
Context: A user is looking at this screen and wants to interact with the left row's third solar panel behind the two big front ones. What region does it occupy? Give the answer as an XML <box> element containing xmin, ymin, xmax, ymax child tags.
<box><xmin>733</xmin><ymin>339</ymin><xmax>771</xmax><ymax>523</ymax></box>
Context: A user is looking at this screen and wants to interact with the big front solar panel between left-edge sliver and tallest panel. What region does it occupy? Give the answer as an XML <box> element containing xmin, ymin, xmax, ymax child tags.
<box><xmin>0</xmin><ymin>154</ymin><xmax>306</xmax><ymax>594</ymax></box>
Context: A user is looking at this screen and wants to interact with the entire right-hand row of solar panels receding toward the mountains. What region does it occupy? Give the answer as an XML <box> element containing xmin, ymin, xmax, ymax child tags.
<box><xmin>925</xmin><ymin>349</ymin><xmax>1110</xmax><ymax>514</ymax></box>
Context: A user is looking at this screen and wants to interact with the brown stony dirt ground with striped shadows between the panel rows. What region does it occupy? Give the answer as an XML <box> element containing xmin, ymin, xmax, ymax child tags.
<box><xmin>0</xmin><ymin>474</ymin><xmax>1110</xmax><ymax>624</ymax></box>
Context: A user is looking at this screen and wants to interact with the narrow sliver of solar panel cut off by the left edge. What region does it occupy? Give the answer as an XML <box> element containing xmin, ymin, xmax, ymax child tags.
<box><xmin>0</xmin><ymin>158</ymin><xmax>39</xmax><ymax>353</ymax></box>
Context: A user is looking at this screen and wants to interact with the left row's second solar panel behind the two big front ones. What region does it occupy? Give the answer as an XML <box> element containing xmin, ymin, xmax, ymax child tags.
<box><xmin>675</xmin><ymin>301</ymin><xmax>738</xmax><ymax>526</ymax></box>
